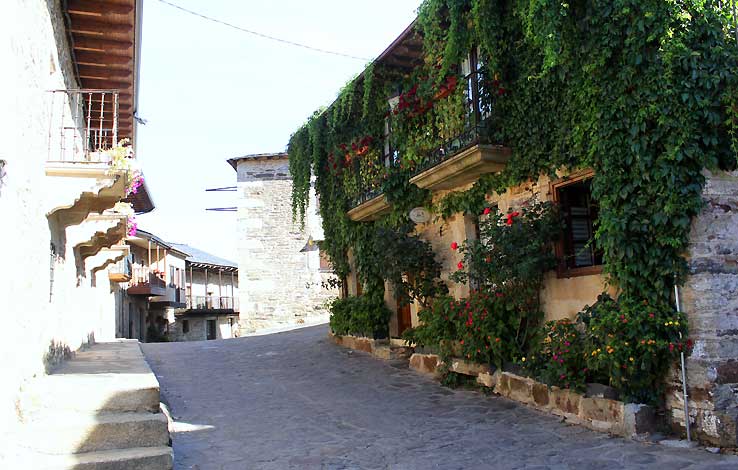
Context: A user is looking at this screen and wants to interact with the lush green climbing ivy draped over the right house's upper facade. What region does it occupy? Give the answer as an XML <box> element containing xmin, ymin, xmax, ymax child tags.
<box><xmin>289</xmin><ymin>0</ymin><xmax>738</xmax><ymax>314</ymax></box>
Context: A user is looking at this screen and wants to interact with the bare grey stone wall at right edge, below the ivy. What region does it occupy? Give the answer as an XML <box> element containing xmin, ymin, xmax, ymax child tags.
<box><xmin>667</xmin><ymin>171</ymin><xmax>738</xmax><ymax>447</ymax></box>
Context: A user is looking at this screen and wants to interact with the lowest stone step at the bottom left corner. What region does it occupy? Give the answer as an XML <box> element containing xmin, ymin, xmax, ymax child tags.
<box><xmin>23</xmin><ymin>446</ymin><xmax>173</xmax><ymax>470</ymax></box>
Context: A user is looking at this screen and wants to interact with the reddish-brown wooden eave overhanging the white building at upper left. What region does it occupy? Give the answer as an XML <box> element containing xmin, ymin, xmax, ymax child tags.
<box><xmin>62</xmin><ymin>0</ymin><xmax>142</xmax><ymax>143</ymax></box>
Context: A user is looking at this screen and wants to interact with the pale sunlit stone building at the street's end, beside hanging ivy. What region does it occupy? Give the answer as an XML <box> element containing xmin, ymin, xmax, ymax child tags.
<box><xmin>228</xmin><ymin>153</ymin><xmax>337</xmax><ymax>332</ymax></box>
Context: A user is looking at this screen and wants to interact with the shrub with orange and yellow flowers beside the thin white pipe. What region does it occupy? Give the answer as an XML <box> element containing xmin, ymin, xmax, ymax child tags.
<box><xmin>579</xmin><ymin>294</ymin><xmax>692</xmax><ymax>403</ymax></box>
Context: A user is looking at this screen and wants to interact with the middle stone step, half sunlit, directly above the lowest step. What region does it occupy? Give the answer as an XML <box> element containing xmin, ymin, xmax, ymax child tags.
<box><xmin>14</xmin><ymin>412</ymin><xmax>169</xmax><ymax>454</ymax></box>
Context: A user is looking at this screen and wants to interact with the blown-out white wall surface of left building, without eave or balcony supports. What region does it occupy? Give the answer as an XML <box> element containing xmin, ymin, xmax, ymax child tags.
<box><xmin>0</xmin><ymin>0</ymin><xmax>131</xmax><ymax>436</ymax></box>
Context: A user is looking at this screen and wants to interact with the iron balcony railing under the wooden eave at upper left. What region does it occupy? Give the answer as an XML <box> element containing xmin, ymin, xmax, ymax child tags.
<box><xmin>48</xmin><ymin>89</ymin><xmax>119</xmax><ymax>163</ymax></box>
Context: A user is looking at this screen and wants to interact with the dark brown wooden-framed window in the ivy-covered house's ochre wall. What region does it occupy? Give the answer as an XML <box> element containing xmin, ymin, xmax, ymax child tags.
<box><xmin>553</xmin><ymin>172</ymin><xmax>602</xmax><ymax>275</ymax></box>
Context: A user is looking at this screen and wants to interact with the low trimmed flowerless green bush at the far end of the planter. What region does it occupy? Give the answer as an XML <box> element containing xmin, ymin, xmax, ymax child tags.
<box><xmin>329</xmin><ymin>295</ymin><xmax>392</xmax><ymax>338</ymax></box>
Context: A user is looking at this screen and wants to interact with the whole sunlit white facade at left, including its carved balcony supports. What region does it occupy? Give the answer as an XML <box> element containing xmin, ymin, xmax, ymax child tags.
<box><xmin>0</xmin><ymin>0</ymin><xmax>153</xmax><ymax>444</ymax></box>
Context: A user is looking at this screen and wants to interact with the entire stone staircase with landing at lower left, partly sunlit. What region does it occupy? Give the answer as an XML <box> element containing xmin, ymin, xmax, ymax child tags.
<box><xmin>11</xmin><ymin>340</ymin><xmax>173</xmax><ymax>470</ymax></box>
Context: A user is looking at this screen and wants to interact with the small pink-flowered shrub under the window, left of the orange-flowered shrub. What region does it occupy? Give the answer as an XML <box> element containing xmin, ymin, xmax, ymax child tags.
<box><xmin>522</xmin><ymin>319</ymin><xmax>589</xmax><ymax>391</ymax></box>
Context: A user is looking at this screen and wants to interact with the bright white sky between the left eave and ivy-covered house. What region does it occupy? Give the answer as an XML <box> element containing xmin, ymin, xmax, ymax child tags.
<box><xmin>137</xmin><ymin>0</ymin><xmax>420</xmax><ymax>260</ymax></box>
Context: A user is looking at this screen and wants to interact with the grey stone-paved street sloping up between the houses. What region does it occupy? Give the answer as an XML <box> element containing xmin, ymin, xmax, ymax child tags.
<box><xmin>143</xmin><ymin>326</ymin><xmax>738</xmax><ymax>470</ymax></box>
